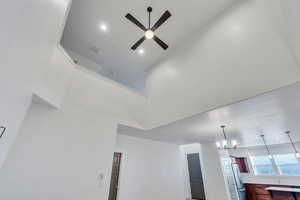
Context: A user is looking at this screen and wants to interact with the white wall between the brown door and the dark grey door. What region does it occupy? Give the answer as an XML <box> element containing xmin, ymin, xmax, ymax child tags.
<box><xmin>115</xmin><ymin>135</ymin><xmax>184</xmax><ymax>200</ymax></box>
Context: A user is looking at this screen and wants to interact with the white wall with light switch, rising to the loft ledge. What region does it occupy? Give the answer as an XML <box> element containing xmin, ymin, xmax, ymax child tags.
<box><xmin>0</xmin><ymin>65</ymin><xmax>146</xmax><ymax>200</ymax></box>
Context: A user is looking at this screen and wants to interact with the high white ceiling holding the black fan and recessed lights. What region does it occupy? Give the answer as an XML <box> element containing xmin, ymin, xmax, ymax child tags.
<box><xmin>62</xmin><ymin>0</ymin><xmax>234</xmax><ymax>90</ymax></box>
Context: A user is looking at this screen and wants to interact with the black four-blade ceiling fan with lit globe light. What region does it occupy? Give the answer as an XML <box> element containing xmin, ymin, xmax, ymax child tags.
<box><xmin>125</xmin><ymin>7</ymin><xmax>171</xmax><ymax>50</ymax></box>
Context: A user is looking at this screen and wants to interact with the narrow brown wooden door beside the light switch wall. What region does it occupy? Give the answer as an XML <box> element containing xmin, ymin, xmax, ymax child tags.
<box><xmin>108</xmin><ymin>153</ymin><xmax>122</xmax><ymax>200</ymax></box>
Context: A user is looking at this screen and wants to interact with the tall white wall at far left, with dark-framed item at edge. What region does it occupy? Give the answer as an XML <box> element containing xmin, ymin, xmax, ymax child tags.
<box><xmin>0</xmin><ymin>0</ymin><xmax>69</xmax><ymax>169</ymax></box>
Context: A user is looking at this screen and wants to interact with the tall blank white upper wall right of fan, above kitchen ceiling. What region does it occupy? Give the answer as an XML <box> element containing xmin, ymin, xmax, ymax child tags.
<box><xmin>146</xmin><ymin>0</ymin><xmax>300</xmax><ymax>126</ymax></box>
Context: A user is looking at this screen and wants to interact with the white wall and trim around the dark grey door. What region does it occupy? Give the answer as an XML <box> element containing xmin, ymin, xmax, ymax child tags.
<box><xmin>180</xmin><ymin>143</ymin><xmax>229</xmax><ymax>200</ymax></box>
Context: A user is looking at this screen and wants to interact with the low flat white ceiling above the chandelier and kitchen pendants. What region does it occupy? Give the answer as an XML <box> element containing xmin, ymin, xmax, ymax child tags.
<box><xmin>119</xmin><ymin>83</ymin><xmax>300</xmax><ymax>146</ymax></box>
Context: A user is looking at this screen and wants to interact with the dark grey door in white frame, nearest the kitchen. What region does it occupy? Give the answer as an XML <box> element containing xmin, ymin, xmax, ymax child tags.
<box><xmin>187</xmin><ymin>153</ymin><xmax>205</xmax><ymax>200</ymax></box>
